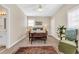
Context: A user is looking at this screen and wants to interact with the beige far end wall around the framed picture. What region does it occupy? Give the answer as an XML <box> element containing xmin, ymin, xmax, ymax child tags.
<box><xmin>28</xmin><ymin>16</ymin><xmax>50</xmax><ymax>34</ymax></box>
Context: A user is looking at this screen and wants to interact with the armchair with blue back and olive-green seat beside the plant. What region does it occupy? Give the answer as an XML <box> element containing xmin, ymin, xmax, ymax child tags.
<box><xmin>58</xmin><ymin>29</ymin><xmax>78</xmax><ymax>54</ymax></box>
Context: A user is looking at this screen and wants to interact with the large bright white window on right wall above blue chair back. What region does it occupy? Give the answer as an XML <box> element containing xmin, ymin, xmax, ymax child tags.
<box><xmin>68</xmin><ymin>8</ymin><xmax>79</xmax><ymax>29</ymax></box>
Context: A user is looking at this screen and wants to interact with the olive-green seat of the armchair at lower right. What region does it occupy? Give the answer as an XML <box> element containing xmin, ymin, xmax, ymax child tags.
<box><xmin>58</xmin><ymin>41</ymin><xmax>76</xmax><ymax>54</ymax></box>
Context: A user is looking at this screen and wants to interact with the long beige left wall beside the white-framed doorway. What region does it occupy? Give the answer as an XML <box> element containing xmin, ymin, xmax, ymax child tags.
<box><xmin>8</xmin><ymin>5</ymin><xmax>26</xmax><ymax>45</ymax></box>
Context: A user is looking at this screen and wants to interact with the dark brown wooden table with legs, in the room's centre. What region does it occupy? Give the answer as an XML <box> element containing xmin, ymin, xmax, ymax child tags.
<box><xmin>29</xmin><ymin>31</ymin><xmax>47</xmax><ymax>44</ymax></box>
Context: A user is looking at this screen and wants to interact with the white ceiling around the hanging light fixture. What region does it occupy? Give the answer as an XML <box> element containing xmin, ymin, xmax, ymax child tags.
<box><xmin>18</xmin><ymin>4</ymin><xmax>62</xmax><ymax>16</ymax></box>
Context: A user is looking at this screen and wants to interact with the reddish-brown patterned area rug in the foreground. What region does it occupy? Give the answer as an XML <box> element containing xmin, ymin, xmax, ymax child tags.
<box><xmin>15</xmin><ymin>46</ymin><xmax>57</xmax><ymax>54</ymax></box>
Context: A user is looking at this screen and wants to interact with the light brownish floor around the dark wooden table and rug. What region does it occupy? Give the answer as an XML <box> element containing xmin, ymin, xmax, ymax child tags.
<box><xmin>2</xmin><ymin>36</ymin><xmax>59</xmax><ymax>54</ymax></box>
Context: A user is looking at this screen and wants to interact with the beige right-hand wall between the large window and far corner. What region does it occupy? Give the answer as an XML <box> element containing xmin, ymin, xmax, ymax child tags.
<box><xmin>51</xmin><ymin>4</ymin><xmax>78</xmax><ymax>39</ymax></box>
